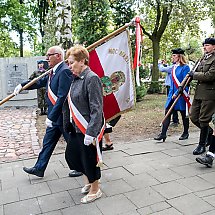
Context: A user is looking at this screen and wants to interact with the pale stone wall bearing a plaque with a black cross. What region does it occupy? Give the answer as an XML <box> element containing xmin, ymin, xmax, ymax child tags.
<box><xmin>0</xmin><ymin>57</ymin><xmax>44</xmax><ymax>108</ymax></box>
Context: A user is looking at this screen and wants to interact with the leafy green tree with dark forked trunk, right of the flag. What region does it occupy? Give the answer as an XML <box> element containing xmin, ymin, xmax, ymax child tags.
<box><xmin>140</xmin><ymin>0</ymin><xmax>212</xmax><ymax>93</ymax></box>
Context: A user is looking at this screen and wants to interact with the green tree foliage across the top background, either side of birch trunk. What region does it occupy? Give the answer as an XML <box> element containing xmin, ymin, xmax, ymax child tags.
<box><xmin>0</xmin><ymin>0</ymin><xmax>215</xmax><ymax>61</ymax></box>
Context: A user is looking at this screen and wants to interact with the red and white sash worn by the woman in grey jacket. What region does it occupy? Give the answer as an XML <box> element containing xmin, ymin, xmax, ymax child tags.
<box><xmin>68</xmin><ymin>90</ymin><xmax>105</xmax><ymax>167</ymax></box>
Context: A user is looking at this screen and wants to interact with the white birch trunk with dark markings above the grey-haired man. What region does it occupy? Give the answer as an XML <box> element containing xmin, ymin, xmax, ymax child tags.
<box><xmin>55</xmin><ymin>0</ymin><xmax>72</xmax><ymax>49</ymax></box>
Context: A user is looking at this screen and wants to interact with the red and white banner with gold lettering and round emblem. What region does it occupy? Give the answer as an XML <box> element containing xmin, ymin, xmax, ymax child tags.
<box><xmin>89</xmin><ymin>30</ymin><xmax>135</xmax><ymax>120</ymax></box>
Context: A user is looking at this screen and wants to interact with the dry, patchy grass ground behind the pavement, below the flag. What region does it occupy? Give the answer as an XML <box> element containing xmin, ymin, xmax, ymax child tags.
<box><xmin>111</xmin><ymin>94</ymin><xmax>198</xmax><ymax>142</ymax></box>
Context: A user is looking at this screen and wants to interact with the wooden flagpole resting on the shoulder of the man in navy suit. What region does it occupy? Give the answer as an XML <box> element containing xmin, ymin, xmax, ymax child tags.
<box><xmin>0</xmin><ymin>22</ymin><xmax>133</xmax><ymax>106</ymax></box>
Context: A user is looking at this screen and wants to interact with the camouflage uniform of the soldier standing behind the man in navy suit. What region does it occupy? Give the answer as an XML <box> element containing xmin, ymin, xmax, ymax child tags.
<box><xmin>29</xmin><ymin>69</ymin><xmax>47</xmax><ymax>115</ymax></box>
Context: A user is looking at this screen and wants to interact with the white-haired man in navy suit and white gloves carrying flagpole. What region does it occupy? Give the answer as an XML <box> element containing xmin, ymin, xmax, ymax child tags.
<box><xmin>14</xmin><ymin>46</ymin><xmax>81</xmax><ymax>177</ymax></box>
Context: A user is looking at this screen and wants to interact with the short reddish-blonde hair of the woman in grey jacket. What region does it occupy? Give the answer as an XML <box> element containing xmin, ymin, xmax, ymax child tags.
<box><xmin>66</xmin><ymin>45</ymin><xmax>89</xmax><ymax>65</ymax></box>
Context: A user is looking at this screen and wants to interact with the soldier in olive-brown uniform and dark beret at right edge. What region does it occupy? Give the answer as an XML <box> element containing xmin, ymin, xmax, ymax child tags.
<box><xmin>190</xmin><ymin>38</ymin><xmax>215</xmax><ymax>155</ymax></box>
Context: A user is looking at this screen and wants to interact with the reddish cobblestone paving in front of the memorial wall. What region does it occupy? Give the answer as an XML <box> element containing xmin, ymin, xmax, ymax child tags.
<box><xmin>0</xmin><ymin>107</ymin><xmax>40</xmax><ymax>162</ymax></box>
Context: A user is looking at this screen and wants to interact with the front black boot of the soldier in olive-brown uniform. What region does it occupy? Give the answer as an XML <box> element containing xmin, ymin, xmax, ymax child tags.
<box><xmin>193</xmin><ymin>126</ymin><xmax>209</xmax><ymax>155</ymax></box>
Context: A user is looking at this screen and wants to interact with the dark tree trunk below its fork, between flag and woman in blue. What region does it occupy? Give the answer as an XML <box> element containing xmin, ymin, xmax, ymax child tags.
<box><xmin>148</xmin><ymin>38</ymin><xmax>160</xmax><ymax>93</ymax></box>
